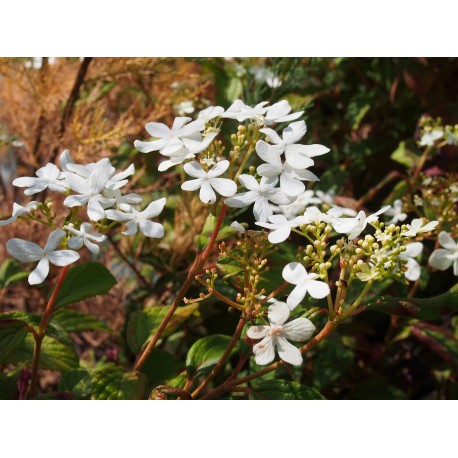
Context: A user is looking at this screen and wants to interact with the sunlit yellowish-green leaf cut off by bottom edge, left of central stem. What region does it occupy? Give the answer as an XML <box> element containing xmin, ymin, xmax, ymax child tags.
<box><xmin>92</xmin><ymin>367</ymin><xmax>146</xmax><ymax>400</ymax></box>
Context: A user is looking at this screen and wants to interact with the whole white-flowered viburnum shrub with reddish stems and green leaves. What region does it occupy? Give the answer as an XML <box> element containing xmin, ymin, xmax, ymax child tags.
<box><xmin>0</xmin><ymin>100</ymin><xmax>458</xmax><ymax>399</ymax></box>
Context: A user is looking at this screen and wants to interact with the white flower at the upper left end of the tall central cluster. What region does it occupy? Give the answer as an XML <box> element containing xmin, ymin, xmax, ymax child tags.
<box><xmin>134</xmin><ymin>117</ymin><xmax>205</xmax><ymax>156</ymax></box>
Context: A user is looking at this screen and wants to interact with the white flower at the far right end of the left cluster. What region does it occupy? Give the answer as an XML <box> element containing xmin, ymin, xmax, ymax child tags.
<box><xmin>105</xmin><ymin>197</ymin><xmax>166</xmax><ymax>238</ymax></box>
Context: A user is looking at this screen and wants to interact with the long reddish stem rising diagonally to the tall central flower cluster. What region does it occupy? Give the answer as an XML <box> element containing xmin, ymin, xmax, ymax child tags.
<box><xmin>134</xmin><ymin>203</ymin><xmax>227</xmax><ymax>371</ymax></box>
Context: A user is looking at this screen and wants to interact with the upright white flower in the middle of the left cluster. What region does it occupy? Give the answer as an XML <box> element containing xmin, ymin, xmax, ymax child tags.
<box><xmin>64</xmin><ymin>167</ymin><xmax>112</xmax><ymax>221</ymax></box>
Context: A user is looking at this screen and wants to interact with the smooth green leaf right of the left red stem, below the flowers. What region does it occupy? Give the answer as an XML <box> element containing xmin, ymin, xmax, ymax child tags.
<box><xmin>54</xmin><ymin>262</ymin><xmax>116</xmax><ymax>308</ymax></box>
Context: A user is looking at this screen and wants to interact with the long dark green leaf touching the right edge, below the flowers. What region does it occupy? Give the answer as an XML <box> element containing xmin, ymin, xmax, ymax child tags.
<box><xmin>363</xmin><ymin>283</ymin><xmax>458</xmax><ymax>320</ymax></box>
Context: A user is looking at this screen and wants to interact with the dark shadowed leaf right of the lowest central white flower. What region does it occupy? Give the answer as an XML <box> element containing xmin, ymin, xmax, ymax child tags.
<box><xmin>313</xmin><ymin>334</ymin><xmax>354</xmax><ymax>390</ymax></box>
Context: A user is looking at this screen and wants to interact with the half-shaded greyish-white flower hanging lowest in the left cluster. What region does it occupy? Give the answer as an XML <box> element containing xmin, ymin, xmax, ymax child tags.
<box><xmin>6</xmin><ymin>229</ymin><xmax>80</xmax><ymax>285</ymax></box>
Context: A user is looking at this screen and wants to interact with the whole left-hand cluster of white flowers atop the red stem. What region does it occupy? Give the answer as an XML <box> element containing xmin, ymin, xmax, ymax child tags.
<box><xmin>0</xmin><ymin>150</ymin><xmax>166</xmax><ymax>285</ymax></box>
